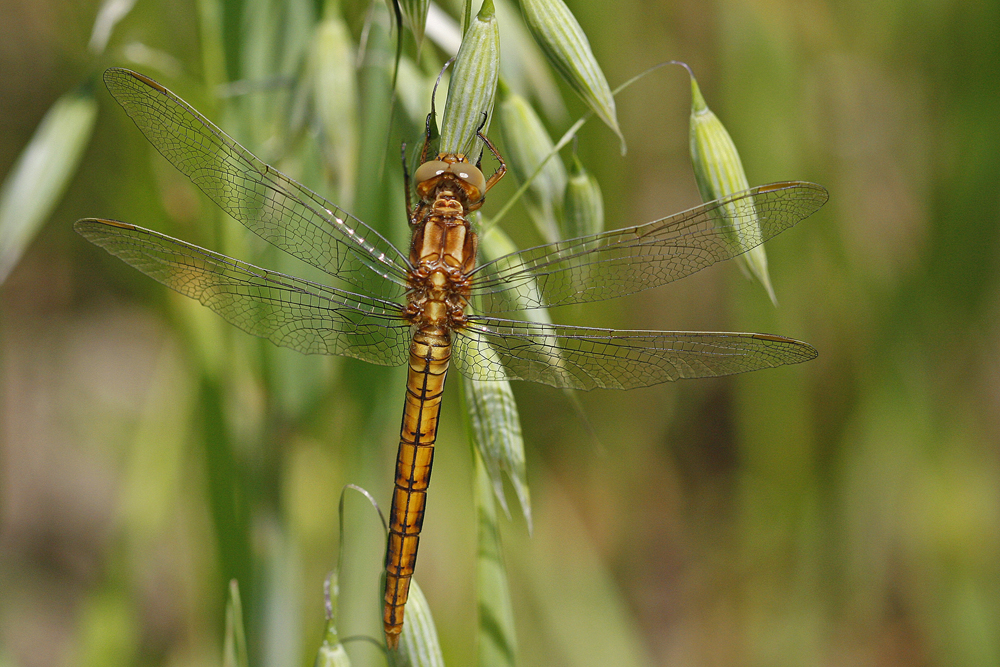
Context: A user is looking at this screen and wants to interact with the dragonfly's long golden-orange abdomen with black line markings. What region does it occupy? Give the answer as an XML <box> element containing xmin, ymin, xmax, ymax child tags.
<box><xmin>383</xmin><ymin>326</ymin><xmax>451</xmax><ymax>648</ymax></box>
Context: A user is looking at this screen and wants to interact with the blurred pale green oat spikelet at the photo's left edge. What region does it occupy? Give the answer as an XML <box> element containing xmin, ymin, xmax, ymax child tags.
<box><xmin>0</xmin><ymin>90</ymin><xmax>97</xmax><ymax>284</ymax></box>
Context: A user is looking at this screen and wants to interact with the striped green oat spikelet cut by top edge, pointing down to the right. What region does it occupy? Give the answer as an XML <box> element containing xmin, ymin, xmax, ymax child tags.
<box><xmin>521</xmin><ymin>0</ymin><xmax>625</xmax><ymax>155</ymax></box>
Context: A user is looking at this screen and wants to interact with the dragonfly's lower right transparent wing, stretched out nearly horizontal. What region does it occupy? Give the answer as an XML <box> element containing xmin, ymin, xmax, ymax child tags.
<box><xmin>453</xmin><ymin>317</ymin><xmax>817</xmax><ymax>390</ymax></box>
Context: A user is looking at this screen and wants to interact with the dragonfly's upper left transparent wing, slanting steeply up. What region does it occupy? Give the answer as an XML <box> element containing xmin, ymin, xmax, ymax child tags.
<box><xmin>104</xmin><ymin>68</ymin><xmax>408</xmax><ymax>299</ymax></box>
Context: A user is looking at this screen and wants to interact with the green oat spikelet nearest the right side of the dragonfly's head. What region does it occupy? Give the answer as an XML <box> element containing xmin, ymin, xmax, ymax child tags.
<box><xmin>499</xmin><ymin>87</ymin><xmax>566</xmax><ymax>243</ymax></box>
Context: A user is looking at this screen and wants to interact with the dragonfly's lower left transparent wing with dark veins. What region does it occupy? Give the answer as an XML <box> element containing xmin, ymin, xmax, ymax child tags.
<box><xmin>74</xmin><ymin>219</ymin><xmax>410</xmax><ymax>366</ymax></box>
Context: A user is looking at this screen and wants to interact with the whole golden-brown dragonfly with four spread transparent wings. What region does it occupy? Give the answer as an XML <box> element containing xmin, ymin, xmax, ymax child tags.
<box><xmin>74</xmin><ymin>68</ymin><xmax>828</xmax><ymax>649</ymax></box>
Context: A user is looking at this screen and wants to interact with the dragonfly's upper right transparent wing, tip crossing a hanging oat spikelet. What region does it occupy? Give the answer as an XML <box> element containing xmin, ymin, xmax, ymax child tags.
<box><xmin>472</xmin><ymin>182</ymin><xmax>829</xmax><ymax>313</ymax></box>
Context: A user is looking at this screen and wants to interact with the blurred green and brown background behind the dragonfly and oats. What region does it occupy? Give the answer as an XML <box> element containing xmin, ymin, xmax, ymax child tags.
<box><xmin>0</xmin><ymin>0</ymin><xmax>1000</xmax><ymax>667</ymax></box>
